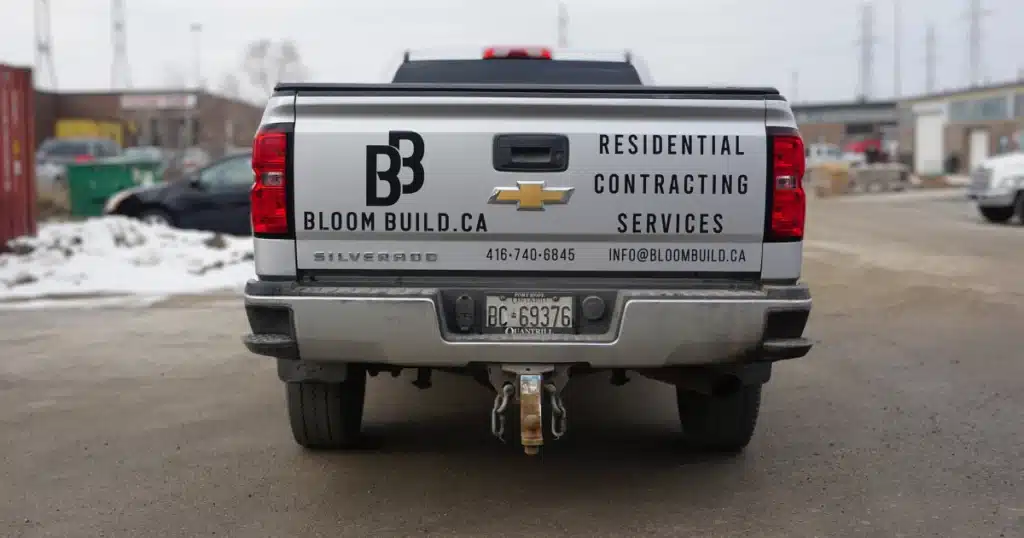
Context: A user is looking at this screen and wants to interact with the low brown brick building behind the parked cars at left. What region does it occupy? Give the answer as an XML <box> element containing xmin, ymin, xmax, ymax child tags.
<box><xmin>36</xmin><ymin>90</ymin><xmax>263</xmax><ymax>156</ymax></box>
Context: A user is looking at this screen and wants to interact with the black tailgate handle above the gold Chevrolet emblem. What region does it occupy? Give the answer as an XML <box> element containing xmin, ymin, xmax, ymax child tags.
<box><xmin>494</xmin><ymin>134</ymin><xmax>569</xmax><ymax>172</ymax></box>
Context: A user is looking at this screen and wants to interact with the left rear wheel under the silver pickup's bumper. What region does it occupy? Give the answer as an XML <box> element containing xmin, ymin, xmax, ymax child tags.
<box><xmin>285</xmin><ymin>367</ymin><xmax>367</xmax><ymax>450</ymax></box>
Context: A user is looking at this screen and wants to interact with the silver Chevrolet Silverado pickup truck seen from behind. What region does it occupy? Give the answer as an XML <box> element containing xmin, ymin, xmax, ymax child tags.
<box><xmin>244</xmin><ymin>47</ymin><xmax>811</xmax><ymax>454</ymax></box>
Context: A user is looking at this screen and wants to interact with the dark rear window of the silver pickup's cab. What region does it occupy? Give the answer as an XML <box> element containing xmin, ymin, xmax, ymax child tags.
<box><xmin>392</xmin><ymin>59</ymin><xmax>642</xmax><ymax>85</ymax></box>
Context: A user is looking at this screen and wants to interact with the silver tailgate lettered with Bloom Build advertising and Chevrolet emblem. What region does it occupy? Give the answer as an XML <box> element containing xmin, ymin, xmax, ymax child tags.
<box><xmin>292</xmin><ymin>90</ymin><xmax>768</xmax><ymax>276</ymax></box>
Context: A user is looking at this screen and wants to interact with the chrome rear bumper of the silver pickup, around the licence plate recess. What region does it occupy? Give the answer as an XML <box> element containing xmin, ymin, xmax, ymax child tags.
<box><xmin>244</xmin><ymin>281</ymin><xmax>811</xmax><ymax>369</ymax></box>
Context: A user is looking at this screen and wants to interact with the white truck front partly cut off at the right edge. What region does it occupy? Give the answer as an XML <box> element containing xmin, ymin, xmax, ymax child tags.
<box><xmin>967</xmin><ymin>151</ymin><xmax>1024</xmax><ymax>223</ymax></box>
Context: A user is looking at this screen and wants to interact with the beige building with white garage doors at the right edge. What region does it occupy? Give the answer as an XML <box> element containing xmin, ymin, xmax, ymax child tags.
<box><xmin>899</xmin><ymin>81</ymin><xmax>1024</xmax><ymax>175</ymax></box>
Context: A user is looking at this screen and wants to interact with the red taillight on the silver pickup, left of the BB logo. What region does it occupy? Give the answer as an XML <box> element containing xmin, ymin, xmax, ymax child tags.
<box><xmin>249</xmin><ymin>130</ymin><xmax>288</xmax><ymax>235</ymax></box>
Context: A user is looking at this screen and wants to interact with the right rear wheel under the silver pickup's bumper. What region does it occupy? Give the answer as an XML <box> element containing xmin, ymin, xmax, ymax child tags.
<box><xmin>676</xmin><ymin>384</ymin><xmax>763</xmax><ymax>454</ymax></box>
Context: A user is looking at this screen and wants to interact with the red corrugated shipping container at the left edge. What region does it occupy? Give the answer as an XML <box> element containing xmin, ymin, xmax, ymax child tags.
<box><xmin>0</xmin><ymin>65</ymin><xmax>36</xmax><ymax>250</ymax></box>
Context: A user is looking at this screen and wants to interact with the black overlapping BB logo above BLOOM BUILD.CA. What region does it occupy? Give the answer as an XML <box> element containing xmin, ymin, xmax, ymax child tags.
<box><xmin>367</xmin><ymin>131</ymin><xmax>423</xmax><ymax>207</ymax></box>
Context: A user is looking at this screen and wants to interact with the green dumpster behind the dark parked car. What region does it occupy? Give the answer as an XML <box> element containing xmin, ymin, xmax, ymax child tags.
<box><xmin>68</xmin><ymin>158</ymin><xmax>162</xmax><ymax>217</ymax></box>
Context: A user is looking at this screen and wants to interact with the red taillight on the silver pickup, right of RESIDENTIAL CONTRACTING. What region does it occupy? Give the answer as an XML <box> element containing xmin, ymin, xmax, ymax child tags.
<box><xmin>766</xmin><ymin>134</ymin><xmax>807</xmax><ymax>241</ymax></box>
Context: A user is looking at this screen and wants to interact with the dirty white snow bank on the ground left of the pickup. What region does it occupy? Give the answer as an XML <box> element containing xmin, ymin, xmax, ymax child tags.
<box><xmin>0</xmin><ymin>217</ymin><xmax>254</xmax><ymax>307</ymax></box>
